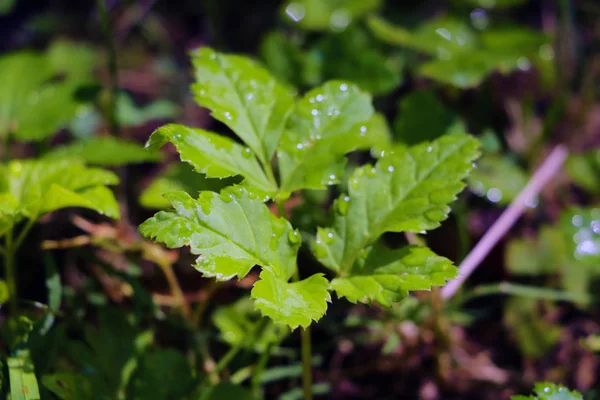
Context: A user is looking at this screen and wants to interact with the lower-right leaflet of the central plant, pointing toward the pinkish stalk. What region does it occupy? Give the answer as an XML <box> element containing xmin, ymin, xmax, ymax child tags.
<box><xmin>331</xmin><ymin>245</ymin><xmax>457</xmax><ymax>307</ymax></box>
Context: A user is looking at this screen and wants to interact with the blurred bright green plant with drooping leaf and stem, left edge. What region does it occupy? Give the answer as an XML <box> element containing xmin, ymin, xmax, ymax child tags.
<box><xmin>0</xmin><ymin>159</ymin><xmax>119</xmax><ymax>309</ymax></box>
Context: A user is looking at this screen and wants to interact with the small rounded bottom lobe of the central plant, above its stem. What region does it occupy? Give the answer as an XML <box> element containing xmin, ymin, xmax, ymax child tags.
<box><xmin>252</xmin><ymin>270</ymin><xmax>331</xmax><ymax>329</ymax></box>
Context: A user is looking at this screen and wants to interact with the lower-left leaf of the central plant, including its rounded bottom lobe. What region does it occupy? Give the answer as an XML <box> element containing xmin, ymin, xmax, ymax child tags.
<box><xmin>140</xmin><ymin>186</ymin><xmax>329</xmax><ymax>328</ymax></box>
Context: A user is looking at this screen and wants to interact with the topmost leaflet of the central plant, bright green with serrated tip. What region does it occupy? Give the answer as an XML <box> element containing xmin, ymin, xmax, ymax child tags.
<box><xmin>192</xmin><ymin>47</ymin><xmax>294</xmax><ymax>165</ymax></box>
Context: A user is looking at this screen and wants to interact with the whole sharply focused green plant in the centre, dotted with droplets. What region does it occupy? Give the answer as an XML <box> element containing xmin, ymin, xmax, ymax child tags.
<box><xmin>140</xmin><ymin>48</ymin><xmax>478</xmax><ymax>395</ymax></box>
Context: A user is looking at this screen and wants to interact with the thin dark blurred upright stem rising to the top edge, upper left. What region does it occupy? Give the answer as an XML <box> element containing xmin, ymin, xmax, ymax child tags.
<box><xmin>96</xmin><ymin>0</ymin><xmax>119</xmax><ymax>137</ymax></box>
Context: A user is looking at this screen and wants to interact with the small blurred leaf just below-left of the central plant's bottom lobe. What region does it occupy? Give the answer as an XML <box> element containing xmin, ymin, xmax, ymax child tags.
<box><xmin>212</xmin><ymin>297</ymin><xmax>288</xmax><ymax>353</ymax></box>
